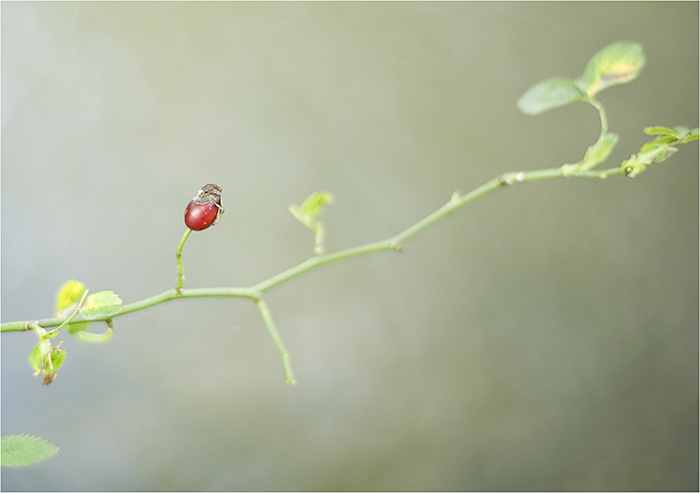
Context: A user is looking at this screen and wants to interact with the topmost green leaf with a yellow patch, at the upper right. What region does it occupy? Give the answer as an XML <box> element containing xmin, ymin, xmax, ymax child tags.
<box><xmin>581</xmin><ymin>42</ymin><xmax>644</xmax><ymax>97</ymax></box>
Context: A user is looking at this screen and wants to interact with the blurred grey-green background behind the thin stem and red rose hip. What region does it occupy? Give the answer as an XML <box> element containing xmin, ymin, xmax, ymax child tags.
<box><xmin>2</xmin><ymin>2</ymin><xmax>698</xmax><ymax>491</ymax></box>
